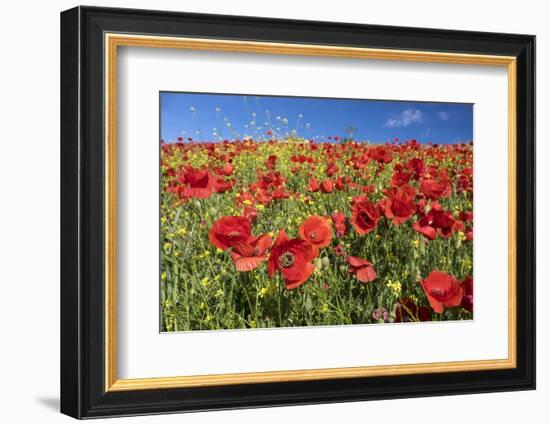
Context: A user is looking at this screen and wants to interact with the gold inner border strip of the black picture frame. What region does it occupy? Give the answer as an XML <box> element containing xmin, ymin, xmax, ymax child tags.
<box><xmin>104</xmin><ymin>33</ymin><xmax>517</xmax><ymax>391</ymax></box>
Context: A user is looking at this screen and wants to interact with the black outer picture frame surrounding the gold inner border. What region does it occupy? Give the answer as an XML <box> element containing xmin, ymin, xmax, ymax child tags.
<box><xmin>61</xmin><ymin>7</ymin><xmax>535</xmax><ymax>418</ymax></box>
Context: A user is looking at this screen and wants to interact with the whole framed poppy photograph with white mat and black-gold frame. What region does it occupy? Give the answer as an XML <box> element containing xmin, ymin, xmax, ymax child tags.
<box><xmin>61</xmin><ymin>7</ymin><xmax>535</xmax><ymax>418</ymax></box>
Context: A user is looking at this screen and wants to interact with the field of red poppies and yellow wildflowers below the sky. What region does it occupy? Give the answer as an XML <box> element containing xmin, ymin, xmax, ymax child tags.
<box><xmin>160</xmin><ymin>137</ymin><xmax>473</xmax><ymax>331</ymax></box>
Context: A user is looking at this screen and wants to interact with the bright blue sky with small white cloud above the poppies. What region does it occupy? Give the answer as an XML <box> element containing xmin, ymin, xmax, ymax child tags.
<box><xmin>160</xmin><ymin>92</ymin><xmax>473</xmax><ymax>144</ymax></box>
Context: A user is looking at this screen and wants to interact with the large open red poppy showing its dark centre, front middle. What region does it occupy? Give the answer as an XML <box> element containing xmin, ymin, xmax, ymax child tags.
<box><xmin>267</xmin><ymin>230</ymin><xmax>315</xmax><ymax>289</ymax></box>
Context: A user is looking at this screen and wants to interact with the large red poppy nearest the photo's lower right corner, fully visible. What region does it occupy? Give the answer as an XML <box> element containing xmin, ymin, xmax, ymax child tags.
<box><xmin>420</xmin><ymin>270</ymin><xmax>464</xmax><ymax>313</ymax></box>
